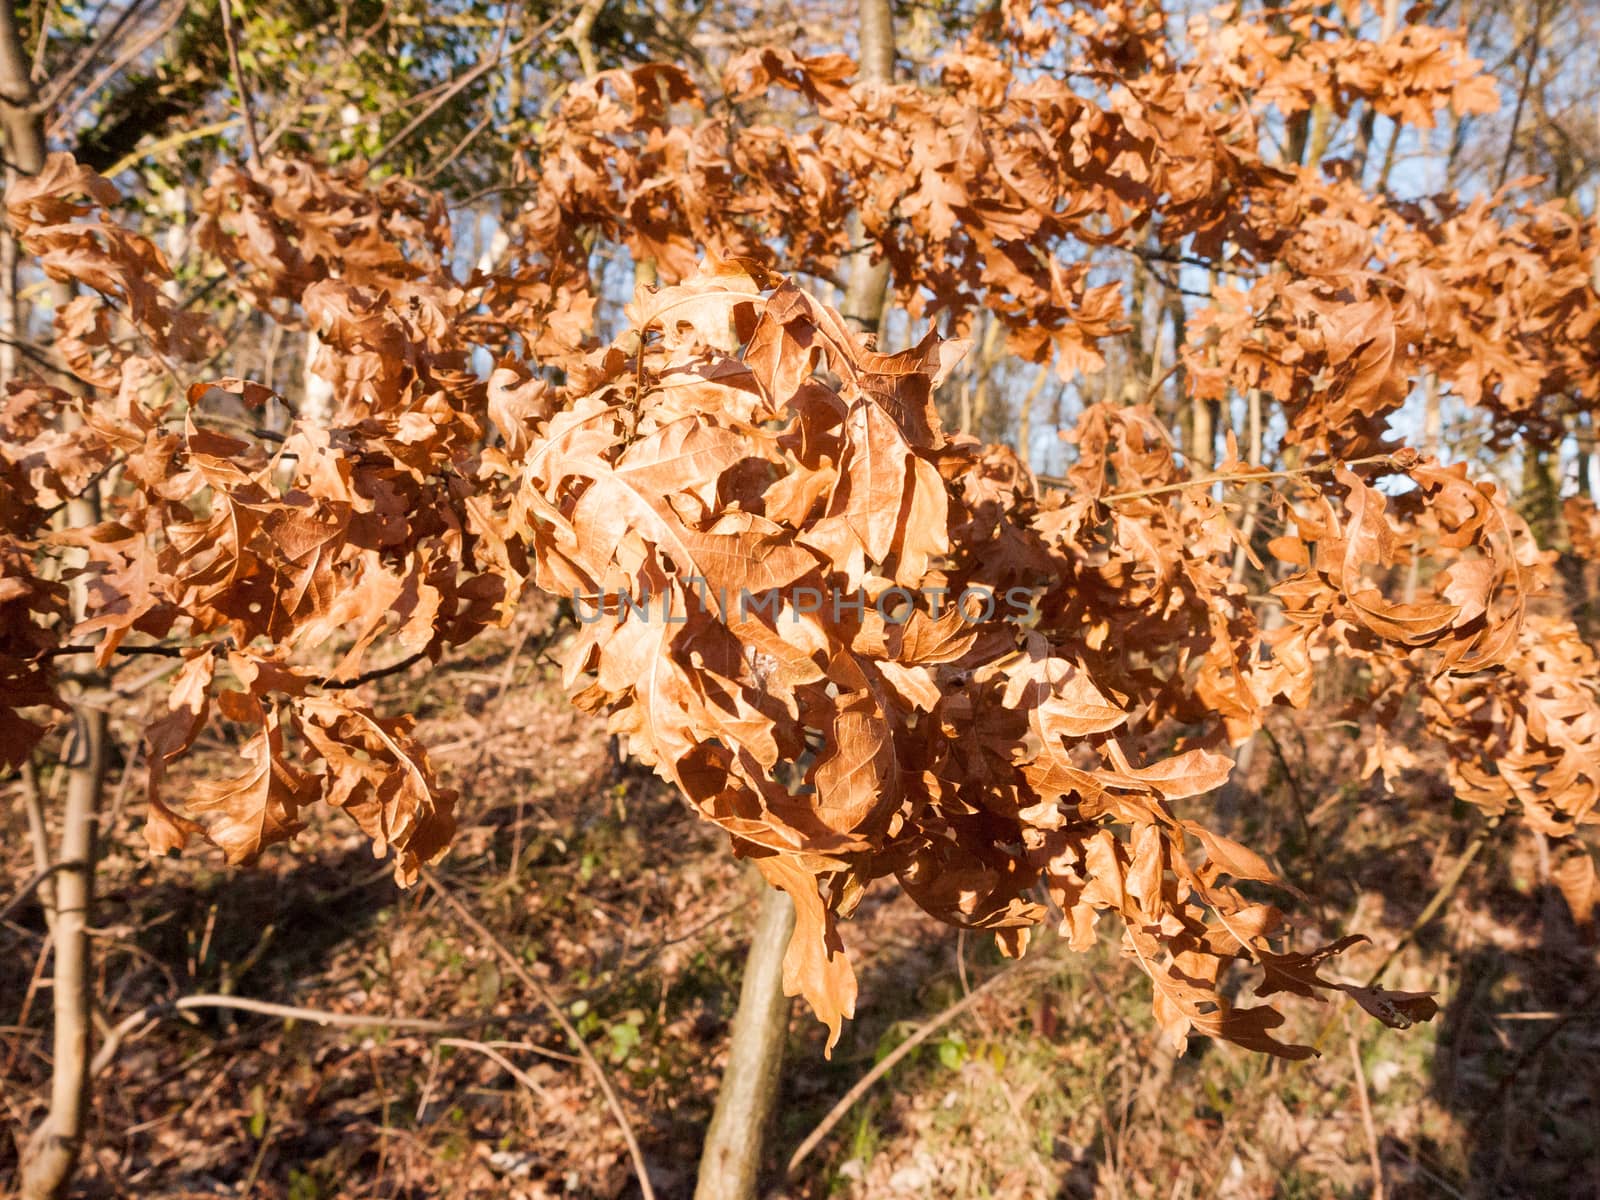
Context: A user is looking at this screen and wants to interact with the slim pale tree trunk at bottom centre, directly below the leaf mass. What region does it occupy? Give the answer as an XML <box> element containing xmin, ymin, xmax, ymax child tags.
<box><xmin>694</xmin><ymin>880</ymin><xmax>795</xmax><ymax>1200</ymax></box>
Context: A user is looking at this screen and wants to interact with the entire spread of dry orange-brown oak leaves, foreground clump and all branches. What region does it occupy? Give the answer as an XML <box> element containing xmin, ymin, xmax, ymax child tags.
<box><xmin>0</xmin><ymin>3</ymin><xmax>1600</xmax><ymax>1056</ymax></box>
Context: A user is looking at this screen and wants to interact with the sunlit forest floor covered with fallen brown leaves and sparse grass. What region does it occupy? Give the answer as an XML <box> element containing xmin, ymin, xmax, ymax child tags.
<box><xmin>0</xmin><ymin>611</ymin><xmax>1600</xmax><ymax>1200</ymax></box>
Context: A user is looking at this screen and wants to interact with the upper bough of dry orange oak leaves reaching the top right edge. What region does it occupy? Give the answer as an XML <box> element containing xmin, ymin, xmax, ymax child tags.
<box><xmin>517</xmin><ymin>0</ymin><xmax>1600</xmax><ymax>456</ymax></box>
